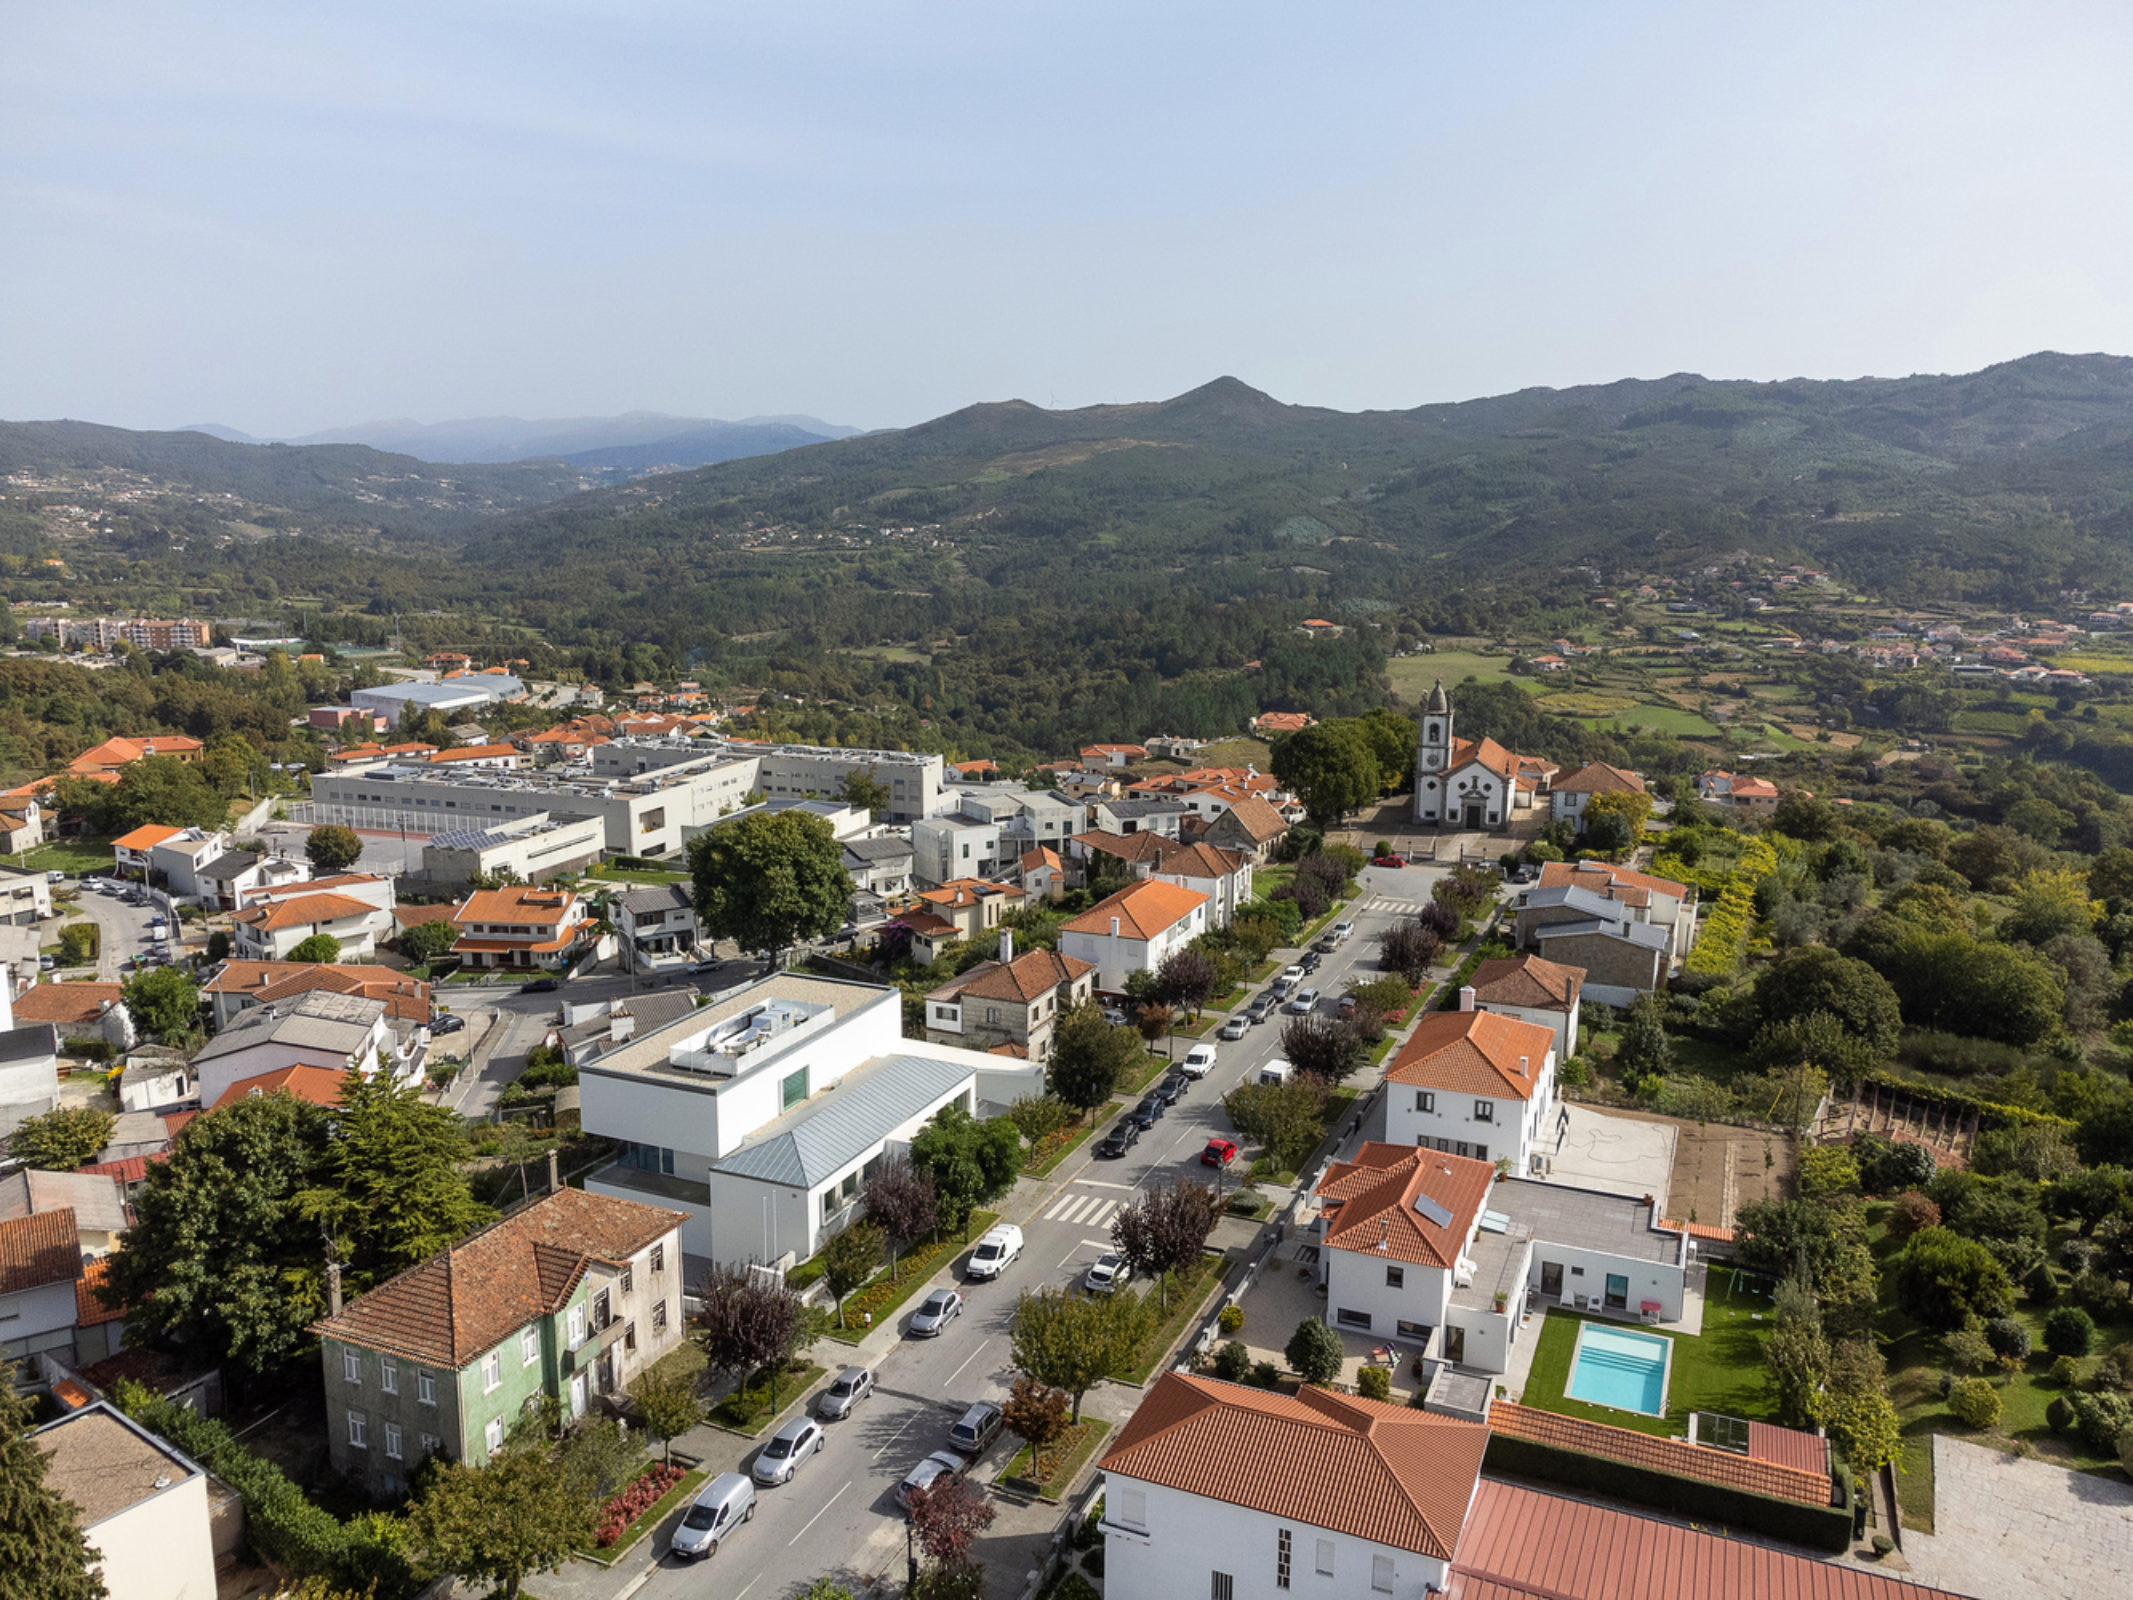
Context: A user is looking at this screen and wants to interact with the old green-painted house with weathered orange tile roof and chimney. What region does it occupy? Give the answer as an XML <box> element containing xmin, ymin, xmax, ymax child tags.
<box><xmin>311</xmin><ymin>1188</ymin><xmax>685</xmax><ymax>1495</ymax></box>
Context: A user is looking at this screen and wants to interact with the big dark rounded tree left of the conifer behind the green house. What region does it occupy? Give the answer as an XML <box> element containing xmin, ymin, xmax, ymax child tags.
<box><xmin>109</xmin><ymin>1094</ymin><xmax>326</xmax><ymax>1374</ymax></box>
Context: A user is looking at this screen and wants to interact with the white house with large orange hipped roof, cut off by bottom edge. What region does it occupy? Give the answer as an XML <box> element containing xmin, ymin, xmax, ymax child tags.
<box><xmin>1101</xmin><ymin>1372</ymin><xmax>1489</xmax><ymax>1600</ymax></box>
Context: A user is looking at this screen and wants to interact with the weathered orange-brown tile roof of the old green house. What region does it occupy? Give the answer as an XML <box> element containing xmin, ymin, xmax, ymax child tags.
<box><xmin>311</xmin><ymin>1188</ymin><xmax>687</xmax><ymax>1372</ymax></box>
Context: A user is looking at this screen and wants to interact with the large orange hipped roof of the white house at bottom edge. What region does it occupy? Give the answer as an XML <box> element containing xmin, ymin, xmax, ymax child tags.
<box><xmin>1101</xmin><ymin>1372</ymin><xmax>1487</xmax><ymax>1559</ymax></box>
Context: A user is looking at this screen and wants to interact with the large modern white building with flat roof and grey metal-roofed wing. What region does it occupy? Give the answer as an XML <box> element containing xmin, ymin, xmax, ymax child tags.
<box><xmin>578</xmin><ymin>973</ymin><xmax>1045</xmax><ymax>1263</ymax></box>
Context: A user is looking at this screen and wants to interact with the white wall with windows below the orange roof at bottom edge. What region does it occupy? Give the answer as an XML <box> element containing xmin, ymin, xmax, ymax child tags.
<box><xmin>1103</xmin><ymin>1474</ymin><xmax>1448</xmax><ymax>1600</ymax></box>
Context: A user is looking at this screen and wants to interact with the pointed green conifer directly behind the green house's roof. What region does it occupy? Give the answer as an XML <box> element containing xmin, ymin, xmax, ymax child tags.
<box><xmin>296</xmin><ymin>1071</ymin><xmax>495</xmax><ymax>1289</ymax></box>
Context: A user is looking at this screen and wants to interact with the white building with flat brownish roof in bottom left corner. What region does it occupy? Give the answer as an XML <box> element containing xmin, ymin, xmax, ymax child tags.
<box><xmin>30</xmin><ymin>1402</ymin><xmax>215</xmax><ymax>1600</ymax></box>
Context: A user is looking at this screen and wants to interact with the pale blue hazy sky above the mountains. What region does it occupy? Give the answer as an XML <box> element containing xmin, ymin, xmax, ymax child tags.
<box><xmin>0</xmin><ymin>0</ymin><xmax>2133</xmax><ymax>433</ymax></box>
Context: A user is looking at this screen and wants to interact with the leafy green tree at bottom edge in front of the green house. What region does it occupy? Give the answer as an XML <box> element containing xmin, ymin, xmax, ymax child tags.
<box><xmin>407</xmin><ymin>1444</ymin><xmax>599</xmax><ymax>1600</ymax></box>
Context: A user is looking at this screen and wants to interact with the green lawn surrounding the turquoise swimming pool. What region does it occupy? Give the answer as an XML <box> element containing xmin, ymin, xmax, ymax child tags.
<box><xmin>1523</xmin><ymin>1267</ymin><xmax>1777</xmax><ymax>1438</ymax></box>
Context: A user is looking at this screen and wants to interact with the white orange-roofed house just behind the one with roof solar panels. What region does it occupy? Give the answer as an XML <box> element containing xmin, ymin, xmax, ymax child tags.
<box><xmin>1384</xmin><ymin>992</ymin><xmax>1555</xmax><ymax>1171</ymax></box>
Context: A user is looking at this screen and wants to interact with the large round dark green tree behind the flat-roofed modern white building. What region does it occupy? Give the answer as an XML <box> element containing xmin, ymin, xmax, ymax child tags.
<box><xmin>689</xmin><ymin>811</ymin><xmax>851</xmax><ymax>954</ymax></box>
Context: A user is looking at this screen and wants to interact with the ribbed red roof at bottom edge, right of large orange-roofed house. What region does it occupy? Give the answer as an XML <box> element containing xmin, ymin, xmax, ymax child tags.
<box><xmin>1446</xmin><ymin>1478</ymin><xmax>1954</xmax><ymax>1600</ymax></box>
